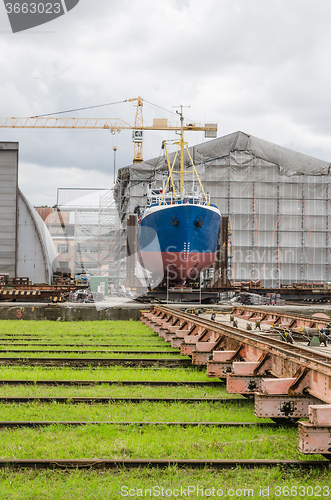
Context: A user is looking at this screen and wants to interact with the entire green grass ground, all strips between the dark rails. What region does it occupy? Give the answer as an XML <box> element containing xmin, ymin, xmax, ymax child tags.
<box><xmin>0</xmin><ymin>320</ymin><xmax>331</xmax><ymax>500</ymax></box>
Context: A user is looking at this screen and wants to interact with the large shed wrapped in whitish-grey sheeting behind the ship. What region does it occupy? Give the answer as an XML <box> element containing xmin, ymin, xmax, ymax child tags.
<box><xmin>115</xmin><ymin>132</ymin><xmax>331</xmax><ymax>287</ymax></box>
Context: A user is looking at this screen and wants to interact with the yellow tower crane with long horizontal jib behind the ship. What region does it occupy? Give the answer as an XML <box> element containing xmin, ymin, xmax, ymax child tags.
<box><xmin>0</xmin><ymin>97</ymin><xmax>217</xmax><ymax>163</ymax></box>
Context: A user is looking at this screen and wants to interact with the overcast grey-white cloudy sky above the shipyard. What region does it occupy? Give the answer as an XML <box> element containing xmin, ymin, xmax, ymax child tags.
<box><xmin>0</xmin><ymin>0</ymin><xmax>331</xmax><ymax>205</ymax></box>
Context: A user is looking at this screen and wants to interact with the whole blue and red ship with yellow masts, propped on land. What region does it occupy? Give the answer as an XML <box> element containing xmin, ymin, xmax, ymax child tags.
<box><xmin>137</xmin><ymin>107</ymin><xmax>221</xmax><ymax>284</ymax></box>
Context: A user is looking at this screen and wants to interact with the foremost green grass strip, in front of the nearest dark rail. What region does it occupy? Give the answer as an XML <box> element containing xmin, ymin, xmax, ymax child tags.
<box><xmin>0</xmin><ymin>467</ymin><xmax>330</xmax><ymax>500</ymax></box>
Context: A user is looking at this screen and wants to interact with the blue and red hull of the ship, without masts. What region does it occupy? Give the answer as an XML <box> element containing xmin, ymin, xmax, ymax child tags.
<box><xmin>138</xmin><ymin>203</ymin><xmax>221</xmax><ymax>283</ymax></box>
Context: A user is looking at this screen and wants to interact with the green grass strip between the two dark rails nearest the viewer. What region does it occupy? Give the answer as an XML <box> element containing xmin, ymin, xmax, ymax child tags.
<box><xmin>0</xmin><ymin>424</ymin><xmax>320</xmax><ymax>460</ymax></box>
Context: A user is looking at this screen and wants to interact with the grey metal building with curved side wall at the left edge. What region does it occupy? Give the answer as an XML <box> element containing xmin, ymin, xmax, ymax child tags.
<box><xmin>0</xmin><ymin>142</ymin><xmax>58</xmax><ymax>284</ymax></box>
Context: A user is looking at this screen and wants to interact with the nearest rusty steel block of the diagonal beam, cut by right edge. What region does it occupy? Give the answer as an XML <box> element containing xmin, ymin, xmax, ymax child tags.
<box><xmin>299</xmin><ymin>405</ymin><xmax>331</xmax><ymax>460</ymax></box>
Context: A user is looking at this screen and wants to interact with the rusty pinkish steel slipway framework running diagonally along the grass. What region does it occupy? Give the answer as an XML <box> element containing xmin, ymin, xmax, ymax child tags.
<box><xmin>142</xmin><ymin>306</ymin><xmax>331</xmax><ymax>459</ymax></box>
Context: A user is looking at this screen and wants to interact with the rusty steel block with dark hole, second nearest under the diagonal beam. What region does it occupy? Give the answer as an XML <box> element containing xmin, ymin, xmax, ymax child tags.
<box><xmin>254</xmin><ymin>392</ymin><xmax>320</xmax><ymax>419</ymax></box>
